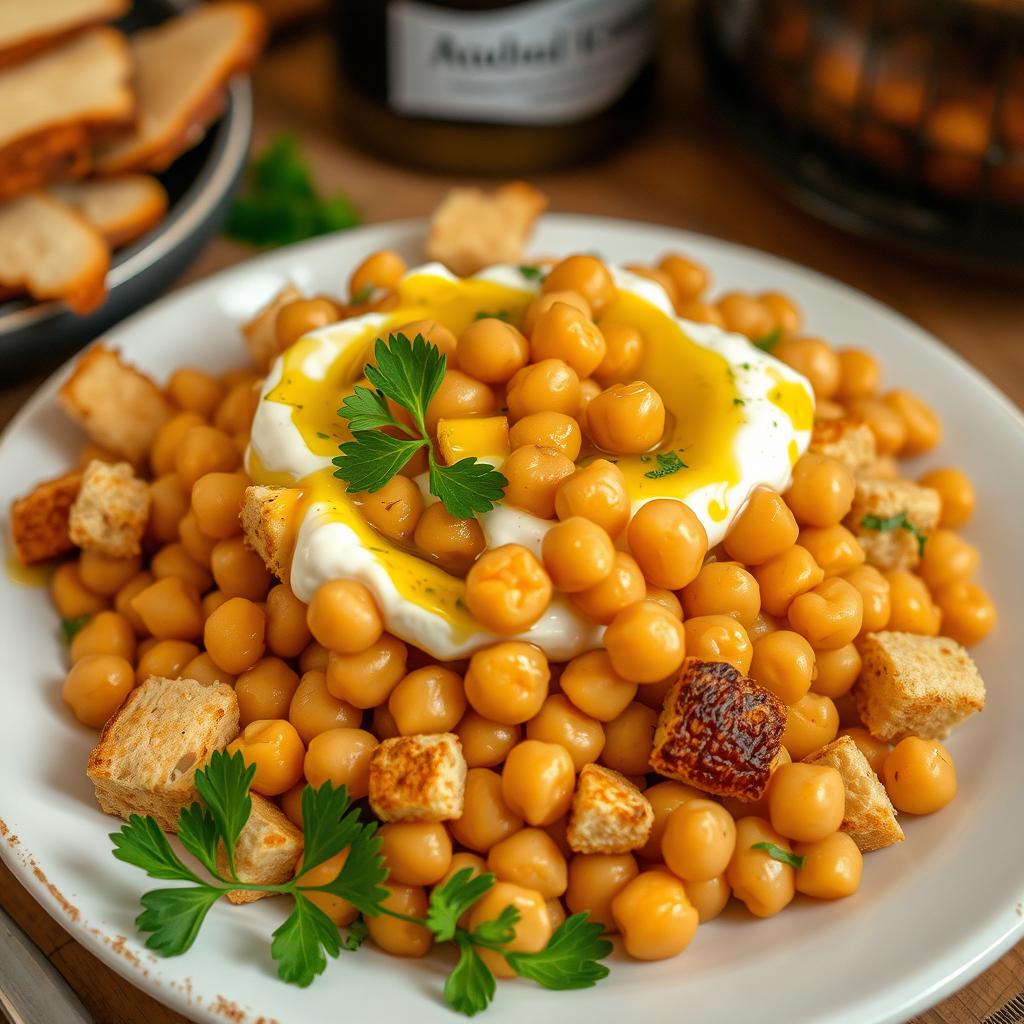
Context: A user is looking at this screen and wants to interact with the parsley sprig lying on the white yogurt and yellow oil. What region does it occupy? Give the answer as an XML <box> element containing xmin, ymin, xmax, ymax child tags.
<box><xmin>333</xmin><ymin>333</ymin><xmax>508</xmax><ymax>519</ymax></box>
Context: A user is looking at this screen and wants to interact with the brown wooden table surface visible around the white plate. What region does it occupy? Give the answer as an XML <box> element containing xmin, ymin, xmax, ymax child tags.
<box><xmin>0</xmin><ymin>10</ymin><xmax>1024</xmax><ymax>1024</ymax></box>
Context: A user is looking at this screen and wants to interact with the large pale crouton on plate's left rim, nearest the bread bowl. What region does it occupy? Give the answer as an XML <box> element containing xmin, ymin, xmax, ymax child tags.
<box><xmin>57</xmin><ymin>345</ymin><xmax>174</xmax><ymax>466</ymax></box>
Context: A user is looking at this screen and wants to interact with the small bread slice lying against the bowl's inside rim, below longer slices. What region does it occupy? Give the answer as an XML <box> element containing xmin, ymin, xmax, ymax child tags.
<box><xmin>49</xmin><ymin>174</ymin><xmax>167</xmax><ymax>249</ymax></box>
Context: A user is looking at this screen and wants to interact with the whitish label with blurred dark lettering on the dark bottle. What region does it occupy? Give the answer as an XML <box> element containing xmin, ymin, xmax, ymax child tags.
<box><xmin>387</xmin><ymin>0</ymin><xmax>655</xmax><ymax>125</ymax></box>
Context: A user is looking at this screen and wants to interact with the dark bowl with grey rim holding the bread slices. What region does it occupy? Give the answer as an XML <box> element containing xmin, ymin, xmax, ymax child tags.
<box><xmin>0</xmin><ymin>0</ymin><xmax>252</xmax><ymax>381</ymax></box>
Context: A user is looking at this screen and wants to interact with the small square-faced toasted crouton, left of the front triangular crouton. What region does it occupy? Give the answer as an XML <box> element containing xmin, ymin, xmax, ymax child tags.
<box><xmin>370</xmin><ymin>732</ymin><xmax>466</xmax><ymax>821</ymax></box>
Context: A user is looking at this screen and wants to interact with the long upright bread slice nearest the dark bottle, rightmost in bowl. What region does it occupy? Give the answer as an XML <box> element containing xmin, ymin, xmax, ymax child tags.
<box><xmin>95</xmin><ymin>2</ymin><xmax>266</xmax><ymax>174</ymax></box>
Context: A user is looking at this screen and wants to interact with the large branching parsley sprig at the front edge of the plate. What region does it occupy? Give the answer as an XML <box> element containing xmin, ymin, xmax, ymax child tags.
<box><xmin>111</xmin><ymin>751</ymin><xmax>611</xmax><ymax>1016</ymax></box>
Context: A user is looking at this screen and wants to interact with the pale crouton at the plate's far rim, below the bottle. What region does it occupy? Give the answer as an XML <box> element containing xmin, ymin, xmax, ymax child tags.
<box><xmin>427</xmin><ymin>181</ymin><xmax>548</xmax><ymax>276</ymax></box>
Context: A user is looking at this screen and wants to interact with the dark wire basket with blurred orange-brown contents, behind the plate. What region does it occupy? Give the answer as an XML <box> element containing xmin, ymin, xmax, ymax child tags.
<box><xmin>700</xmin><ymin>0</ymin><xmax>1024</xmax><ymax>274</ymax></box>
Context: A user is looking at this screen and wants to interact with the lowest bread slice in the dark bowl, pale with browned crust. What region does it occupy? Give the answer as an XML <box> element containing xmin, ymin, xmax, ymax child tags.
<box><xmin>0</xmin><ymin>193</ymin><xmax>111</xmax><ymax>314</ymax></box>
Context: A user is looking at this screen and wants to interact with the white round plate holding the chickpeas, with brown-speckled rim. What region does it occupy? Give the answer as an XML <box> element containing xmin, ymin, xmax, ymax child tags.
<box><xmin>0</xmin><ymin>216</ymin><xmax>1024</xmax><ymax>1024</ymax></box>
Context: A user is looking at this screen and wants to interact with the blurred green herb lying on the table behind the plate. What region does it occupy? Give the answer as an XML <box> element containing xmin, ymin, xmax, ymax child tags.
<box><xmin>224</xmin><ymin>134</ymin><xmax>361</xmax><ymax>248</ymax></box>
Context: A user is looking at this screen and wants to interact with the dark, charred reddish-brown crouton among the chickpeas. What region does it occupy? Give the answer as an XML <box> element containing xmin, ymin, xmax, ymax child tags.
<box><xmin>650</xmin><ymin>658</ymin><xmax>785</xmax><ymax>800</ymax></box>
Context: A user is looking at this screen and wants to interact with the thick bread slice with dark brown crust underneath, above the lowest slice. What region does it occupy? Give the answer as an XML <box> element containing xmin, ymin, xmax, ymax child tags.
<box><xmin>0</xmin><ymin>29</ymin><xmax>135</xmax><ymax>200</ymax></box>
